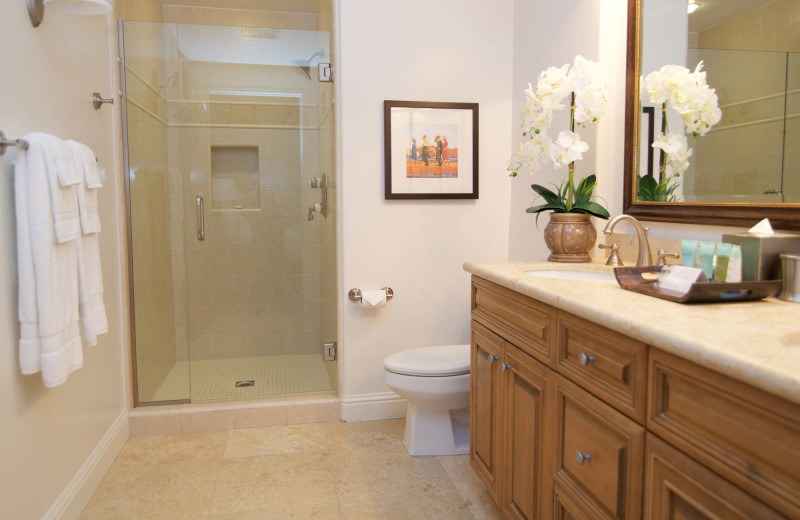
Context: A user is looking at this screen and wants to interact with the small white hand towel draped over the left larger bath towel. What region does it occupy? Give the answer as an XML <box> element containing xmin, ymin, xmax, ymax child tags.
<box><xmin>26</xmin><ymin>132</ymin><xmax>81</xmax><ymax>244</ymax></box>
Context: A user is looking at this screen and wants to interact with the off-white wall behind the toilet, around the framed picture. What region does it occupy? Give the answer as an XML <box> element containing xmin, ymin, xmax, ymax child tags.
<box><xmin>336</xmin><ymin>0</ymin><xmax>513</xmax><ymax>420</ymax></box>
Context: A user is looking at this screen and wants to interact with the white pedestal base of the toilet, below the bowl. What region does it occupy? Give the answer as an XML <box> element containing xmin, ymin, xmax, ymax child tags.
<box><xmin>403</xmin><ymin>403</ymin><xmax>469</xmax><ymax>456</ymax></box>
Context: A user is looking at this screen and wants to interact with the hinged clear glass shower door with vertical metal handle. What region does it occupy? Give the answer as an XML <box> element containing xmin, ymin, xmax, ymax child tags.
<box><xmin>120</xmin><ymin>18</ymin><xmax>336</xmax><ymax>400</ymax></box>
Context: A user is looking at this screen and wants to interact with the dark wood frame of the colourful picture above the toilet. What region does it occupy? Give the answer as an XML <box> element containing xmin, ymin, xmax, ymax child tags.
<box><xmin>383</xmin><ymin>100</ymin><xmax>479</xmax><ymax>200</ymax></box>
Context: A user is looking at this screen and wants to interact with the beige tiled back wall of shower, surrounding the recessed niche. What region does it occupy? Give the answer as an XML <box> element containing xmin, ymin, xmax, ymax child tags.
<box><xmin>169</xmin><ymin>61</ymin><xmax>323</xmax><ymax>360</ymax></box>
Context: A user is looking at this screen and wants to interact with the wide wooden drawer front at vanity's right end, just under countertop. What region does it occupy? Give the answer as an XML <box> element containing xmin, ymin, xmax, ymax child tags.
<box><xmin>647</xmin><ymin>349</ymin><xmax>800</xmax><ymax>518</ymax></box>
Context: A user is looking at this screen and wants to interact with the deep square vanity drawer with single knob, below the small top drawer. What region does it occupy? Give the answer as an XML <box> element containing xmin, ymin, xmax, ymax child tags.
<box><xmin>555</xmin><ymin>376</ymin><xmax>644</xmax><ymax>519</ymax></box>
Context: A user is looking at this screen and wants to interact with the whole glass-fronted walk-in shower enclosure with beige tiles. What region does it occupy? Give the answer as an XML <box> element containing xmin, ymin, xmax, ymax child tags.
<box><xmin>120</xmin><ymin>17</ymin><xmax>336</xmax><ymax>404</ymax></box>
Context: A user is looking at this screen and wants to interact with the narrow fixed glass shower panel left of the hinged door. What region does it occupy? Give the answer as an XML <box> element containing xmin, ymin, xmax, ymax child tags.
<box><xmin>121</xmin><ymin>22</ymin><xmax>190</xmax><ymax>402</ymax></box>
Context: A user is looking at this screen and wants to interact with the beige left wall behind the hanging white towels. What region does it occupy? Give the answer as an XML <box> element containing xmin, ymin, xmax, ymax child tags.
<box><xmin>0</xmin><ymin>2</ymin><xmax>127</xmax><ymax>520</ymax></box>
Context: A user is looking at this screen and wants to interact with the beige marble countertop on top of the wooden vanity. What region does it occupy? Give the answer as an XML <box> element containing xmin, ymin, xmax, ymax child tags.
<box><xmin>464</xmin><ymin>261</ymin><xmax>800</xmax><ymax>404</ymax></box>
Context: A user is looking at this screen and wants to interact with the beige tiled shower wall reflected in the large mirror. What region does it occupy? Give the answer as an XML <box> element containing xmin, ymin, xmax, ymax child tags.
<box><xmin>684</xmin><ymin>5</ymin><xmax>800</xmax><ymax>203</ymax></box>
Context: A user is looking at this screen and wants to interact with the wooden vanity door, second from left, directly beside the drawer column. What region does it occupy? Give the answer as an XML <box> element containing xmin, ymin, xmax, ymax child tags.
<box><xmin>501</xmin><ymin>343</ymin><xmax>554</xmax><ymax>520</ymax></box>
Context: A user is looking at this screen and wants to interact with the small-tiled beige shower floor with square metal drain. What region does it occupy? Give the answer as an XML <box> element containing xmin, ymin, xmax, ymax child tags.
<box><xmin>153</xmin><ymin>354</ymin><xmax>335</xmax><ymax>401</ymax></box>
